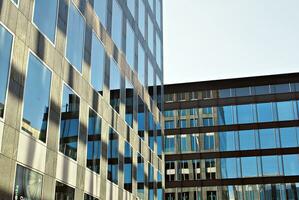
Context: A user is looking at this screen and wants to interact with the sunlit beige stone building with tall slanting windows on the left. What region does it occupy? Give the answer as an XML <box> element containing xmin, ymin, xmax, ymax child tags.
<box><xmin>0</xmin><ymin>0</ymin><xmax>164</xmax><ymax>200</ymax></box>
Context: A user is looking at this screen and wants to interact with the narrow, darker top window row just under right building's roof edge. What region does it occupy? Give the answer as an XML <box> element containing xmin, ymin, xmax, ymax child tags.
<box><xmin>165</xmin><ymin>83</ymin><xmax>299</xmax><ymax>102</ymax></box>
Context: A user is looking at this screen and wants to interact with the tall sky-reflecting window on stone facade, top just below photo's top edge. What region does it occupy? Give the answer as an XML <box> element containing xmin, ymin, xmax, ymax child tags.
<box><xmin>66</xmin><ymin>3</ymin><xmax>85</xmax><ymax>72</ymax></box>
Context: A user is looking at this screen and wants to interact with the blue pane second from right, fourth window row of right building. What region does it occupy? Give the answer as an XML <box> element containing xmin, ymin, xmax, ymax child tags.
<box><xmin>262</xmin><ymin>156</ymin><xmax>281</xmax><ymax>176</ymax></box>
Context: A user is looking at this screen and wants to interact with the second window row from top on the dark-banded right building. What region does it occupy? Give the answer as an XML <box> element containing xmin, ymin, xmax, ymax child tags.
<box><xmin>165</xmin><ymin>101</ymin><xmax>299</xmax><ymax>129</ymax></box>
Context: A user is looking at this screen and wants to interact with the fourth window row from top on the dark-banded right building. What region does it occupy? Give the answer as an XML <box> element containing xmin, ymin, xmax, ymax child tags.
<box><xmin>165</xmin><ymin>154</ymin><xmax>299</xmax><ymax>181</ymax></box>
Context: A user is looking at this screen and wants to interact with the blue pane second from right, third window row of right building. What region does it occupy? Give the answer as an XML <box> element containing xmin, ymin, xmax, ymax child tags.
<box><xmin>259</xmin><ymin>129</ymin><xmax>279</xmax><ymax>149</ymax></box>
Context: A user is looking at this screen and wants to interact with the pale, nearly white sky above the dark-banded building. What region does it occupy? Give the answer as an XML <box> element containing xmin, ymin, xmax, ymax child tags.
<box><xmin>163</xmin><ymin>0</ymin><xmax>299</xmax><ymax>83</ymax></box>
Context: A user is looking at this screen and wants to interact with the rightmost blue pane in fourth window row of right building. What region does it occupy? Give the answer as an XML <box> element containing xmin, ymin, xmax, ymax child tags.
<box><xmin>282</xmin><ymin>154</ymin><xmax>299</xmax><ymax>176</ymax></box>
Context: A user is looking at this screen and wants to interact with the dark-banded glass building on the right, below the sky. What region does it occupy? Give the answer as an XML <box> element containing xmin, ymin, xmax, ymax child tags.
<box><xmin>164</xmin><ymin>73</ymin><xmax>299</xmax><ymax>200</ymax></box>
